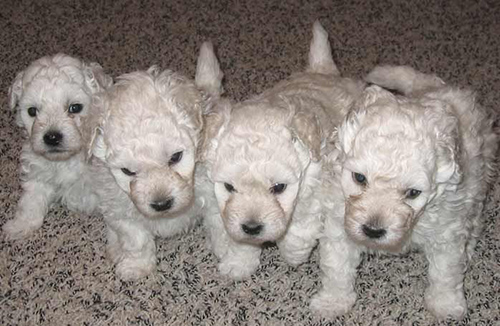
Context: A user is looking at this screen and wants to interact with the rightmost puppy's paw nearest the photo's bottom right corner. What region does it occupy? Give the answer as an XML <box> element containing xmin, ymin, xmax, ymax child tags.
<box><xmin>425</xmin><ymin>288</ymin><xmax>467</xmax><ymax>320</ymax></box>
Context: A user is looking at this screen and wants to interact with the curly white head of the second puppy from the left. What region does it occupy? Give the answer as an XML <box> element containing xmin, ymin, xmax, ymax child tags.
<box><xmin>93</xmin><ymin>67</ymin><xmax>203</xmax><ymax>218</ymax></box>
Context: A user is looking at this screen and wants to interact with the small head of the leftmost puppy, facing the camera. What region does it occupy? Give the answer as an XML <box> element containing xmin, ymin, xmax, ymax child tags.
<box><xmin>9</xmin><ymin>54</ymin><xmax>111</xmax><ymax>160</ymax></box>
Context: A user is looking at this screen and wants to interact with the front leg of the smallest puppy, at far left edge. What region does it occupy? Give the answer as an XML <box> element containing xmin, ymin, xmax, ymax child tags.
<box><xmin>3</xmin><ymin>180</ymin><xmax>55</xmax><ymax>239</ymax></box>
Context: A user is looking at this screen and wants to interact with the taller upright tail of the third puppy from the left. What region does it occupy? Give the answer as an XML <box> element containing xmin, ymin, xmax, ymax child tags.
<box><xmin>307</xmin><ymin>20</ymin><xmax>340</xmax><ymax>76</ymax></box>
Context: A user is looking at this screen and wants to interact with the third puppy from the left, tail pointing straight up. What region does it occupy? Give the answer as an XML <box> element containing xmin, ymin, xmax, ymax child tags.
<box><xmin>196</xmin><ymin>22</ymin><xmax>363</xmax><ymax>279</ymax></box>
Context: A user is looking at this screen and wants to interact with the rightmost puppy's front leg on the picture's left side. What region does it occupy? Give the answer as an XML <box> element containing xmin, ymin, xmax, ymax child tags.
<box><xmin>310</xmin><ymin>230</ymin><xmax>361</xmax><ymax>318</ymax></box>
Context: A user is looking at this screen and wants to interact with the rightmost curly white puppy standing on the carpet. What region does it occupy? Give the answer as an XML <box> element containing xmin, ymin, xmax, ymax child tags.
<box><xmin>311</xmin><ymin>66</ymin><xmax>497</xmax><ymax>319</ymax></box>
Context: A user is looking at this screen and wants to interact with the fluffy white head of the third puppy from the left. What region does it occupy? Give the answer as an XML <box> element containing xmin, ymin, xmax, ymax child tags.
<box><xmin>205</xmin><ymin>100</ymin><xmax>319</xmax><ymax>244</ymax></box>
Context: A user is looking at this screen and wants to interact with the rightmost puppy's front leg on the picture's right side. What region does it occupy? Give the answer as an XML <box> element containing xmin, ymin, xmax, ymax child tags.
<box><xmin>424</xmin><ymin>241</ymin><xmax>467</xmax><ymax>319</ymax></box>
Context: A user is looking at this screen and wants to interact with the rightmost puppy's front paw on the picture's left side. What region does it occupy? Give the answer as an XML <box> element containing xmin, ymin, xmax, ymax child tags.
<box><xmin>309</xmin><ymin>291</ymin><xmax>357</xmax><ymax>319</ymax></box>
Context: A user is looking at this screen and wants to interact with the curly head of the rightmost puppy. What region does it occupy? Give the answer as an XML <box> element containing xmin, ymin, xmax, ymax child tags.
<box><xmin>337</xmin><ymin>86</ymin><xmax>461</xmax><ymax>251</ymax></box>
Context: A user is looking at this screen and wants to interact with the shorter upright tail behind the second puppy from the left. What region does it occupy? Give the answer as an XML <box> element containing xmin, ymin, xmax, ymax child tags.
<box><xmin>195</xmin><ymin>42</ymin><xmax>224</xmax><ymax>97</ymax></box>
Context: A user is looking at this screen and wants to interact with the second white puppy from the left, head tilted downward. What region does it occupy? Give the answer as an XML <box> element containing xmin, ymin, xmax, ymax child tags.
<box><xmin>92</xmin><ymin>60</ymin><xmax>214</xmax><ymax>280</ymax></box>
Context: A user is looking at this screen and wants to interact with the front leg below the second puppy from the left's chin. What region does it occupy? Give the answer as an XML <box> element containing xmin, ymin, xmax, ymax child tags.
<box><xmin>107</xmin><ymin>220</ymin><xmax>156</xmax><ymax>281</ymax></box>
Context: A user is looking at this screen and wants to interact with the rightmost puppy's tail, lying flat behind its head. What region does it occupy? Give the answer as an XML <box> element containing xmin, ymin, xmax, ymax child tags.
<box><xmin>365</xmin><ymin>66</ymin><xmax>445</xmax><ymax>95</ymax></box>
